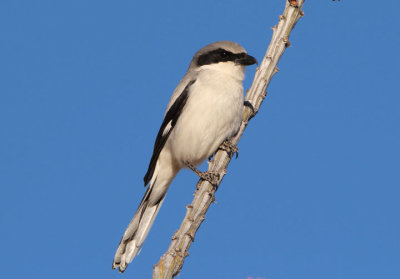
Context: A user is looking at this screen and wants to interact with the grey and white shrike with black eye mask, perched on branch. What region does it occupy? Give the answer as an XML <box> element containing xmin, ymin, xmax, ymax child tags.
<box><xmin>112</xmin><ymin>41</ymin><xmax>257</xmax><ymax>272</ymax></box>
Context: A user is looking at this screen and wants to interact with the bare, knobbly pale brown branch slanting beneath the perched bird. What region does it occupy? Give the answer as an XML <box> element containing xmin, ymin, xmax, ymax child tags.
<box><xmin>153</xmin><ymin>0</ymin><xmax>304</xmax><ymax>279</ymax></box>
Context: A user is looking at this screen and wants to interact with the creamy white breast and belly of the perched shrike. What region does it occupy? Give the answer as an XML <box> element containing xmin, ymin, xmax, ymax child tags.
<box><xmin>167</xmin><ymin>66</ymin><xmax>243</xmax><ymax>165</ymax></box>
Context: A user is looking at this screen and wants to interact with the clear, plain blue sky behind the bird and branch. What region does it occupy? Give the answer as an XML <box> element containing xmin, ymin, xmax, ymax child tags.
<box><xmin>0</xmin><ymin>0</ymin><xmax>400</xmax><ymax>279</ymax></box>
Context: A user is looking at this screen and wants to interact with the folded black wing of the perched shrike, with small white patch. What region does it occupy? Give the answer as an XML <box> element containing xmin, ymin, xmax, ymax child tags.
<box><xmin>143</xmin><ymin>80</ymin><xmax>195</xmax><ymax>186</ymax></box>
